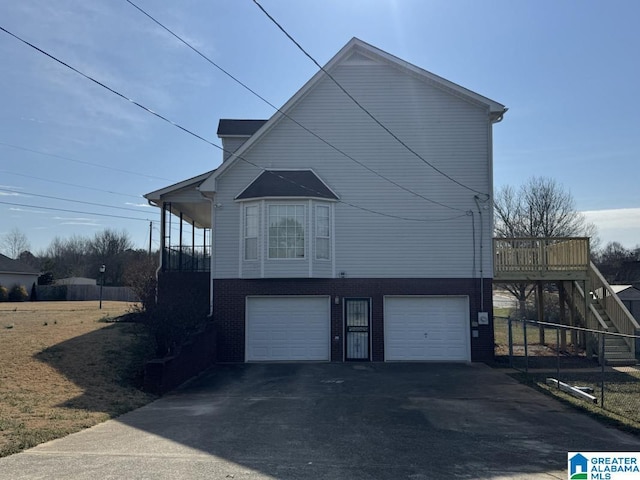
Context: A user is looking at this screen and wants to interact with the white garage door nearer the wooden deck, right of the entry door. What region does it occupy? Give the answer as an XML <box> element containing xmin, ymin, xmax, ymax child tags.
<box><xmin>384</xmin><ymin>297</ymin><xmax>470</xmax><ymax>361</ymax></box>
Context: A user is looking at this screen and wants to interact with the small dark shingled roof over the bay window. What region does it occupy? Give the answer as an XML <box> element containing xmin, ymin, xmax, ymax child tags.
<box><xmin>236</xmin><ymin>170</ymin><xmax>338</xmax><ymax>200</ymax></box>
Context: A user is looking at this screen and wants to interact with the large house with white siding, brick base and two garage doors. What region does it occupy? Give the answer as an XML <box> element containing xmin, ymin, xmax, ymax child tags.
<box><xmin>145</xmin><ymin>39</ymin><xmax>506</xmax><ymax>362</ymax></box>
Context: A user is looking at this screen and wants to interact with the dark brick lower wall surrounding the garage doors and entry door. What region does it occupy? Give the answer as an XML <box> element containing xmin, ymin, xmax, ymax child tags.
<box><xmin>214</xmin><ymin>278</ymin><xmax>494</xmax><ymax>362</ymax></box>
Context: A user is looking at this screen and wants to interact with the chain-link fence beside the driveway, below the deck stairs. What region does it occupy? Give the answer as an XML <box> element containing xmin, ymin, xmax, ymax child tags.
<box><xmin>494</xmin><ymin>317</ymin><xmax>640</xmax><ymax>424</ymax></box>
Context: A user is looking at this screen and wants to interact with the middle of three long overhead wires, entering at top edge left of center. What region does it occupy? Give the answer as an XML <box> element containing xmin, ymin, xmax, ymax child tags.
<box><xmin>125</xmin><ymin>0</ymin><xmax>463</xmax><ymax>211</ymax></box>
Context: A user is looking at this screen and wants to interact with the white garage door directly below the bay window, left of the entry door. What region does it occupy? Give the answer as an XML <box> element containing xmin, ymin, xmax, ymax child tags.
<box><xmin>246</xmin><ymin>297</ymin><xmax>331</xmax><ymax>362</ymax></box>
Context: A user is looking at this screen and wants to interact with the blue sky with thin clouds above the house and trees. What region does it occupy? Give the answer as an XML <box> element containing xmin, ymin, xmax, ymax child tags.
<box><xmin>0</xmin><ymin>0</ymin><xmax>640</xmax><ymax>252</ymax></box>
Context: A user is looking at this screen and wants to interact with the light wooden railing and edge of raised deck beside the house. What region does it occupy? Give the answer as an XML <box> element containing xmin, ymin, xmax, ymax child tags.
<box><xmin>493</xmin><ymin>237</ymin><xmax>589</xmax><ymax>282</ymax></box>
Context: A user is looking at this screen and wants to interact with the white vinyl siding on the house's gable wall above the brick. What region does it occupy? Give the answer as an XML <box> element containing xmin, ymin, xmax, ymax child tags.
<box><xmin>214</xmin><ymin>58</ymin><xmax>493</xmax><ymax>278</ymax></box>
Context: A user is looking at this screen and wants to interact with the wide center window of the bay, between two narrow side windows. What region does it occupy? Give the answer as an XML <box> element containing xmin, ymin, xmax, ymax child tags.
<box><xmin>268</xmin><ymin>205</ymin><xmax>306</xmax><ymax>259</ymax></box>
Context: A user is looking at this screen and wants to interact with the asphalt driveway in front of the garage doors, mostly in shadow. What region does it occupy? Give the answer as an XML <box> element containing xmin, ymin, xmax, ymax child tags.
<box><xmin>0</xmin><ymin>363</ymin><xmax>640</xmax><ymax>480</ymax></box>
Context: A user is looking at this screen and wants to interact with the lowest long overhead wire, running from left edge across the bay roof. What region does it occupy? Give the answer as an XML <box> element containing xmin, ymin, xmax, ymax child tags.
<box><xmin>0</xmin><ymin>26</ymin><xmax>466</xmax><ymax>222</ymax></box>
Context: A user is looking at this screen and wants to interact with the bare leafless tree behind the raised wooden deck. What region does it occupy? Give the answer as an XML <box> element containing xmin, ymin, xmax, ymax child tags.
<box><xmin>494</xmin><ymin>177</ymin><xmax>598</xmax><ymax>315</ymax></box>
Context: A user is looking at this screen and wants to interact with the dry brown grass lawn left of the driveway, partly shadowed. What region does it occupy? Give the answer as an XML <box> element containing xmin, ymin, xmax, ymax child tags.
<box><xmin>0</xmin><ymin>302</ymin><xmax>154</xmax><ymax>456</ymax></box>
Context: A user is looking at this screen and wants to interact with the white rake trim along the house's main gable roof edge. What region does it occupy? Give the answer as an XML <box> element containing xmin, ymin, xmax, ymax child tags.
<box><xmin>201</xmin><ymin>37</ymin><xmax>507</xmax><ymax>192</ymax></box>
